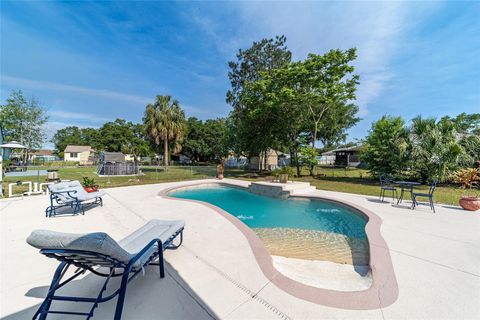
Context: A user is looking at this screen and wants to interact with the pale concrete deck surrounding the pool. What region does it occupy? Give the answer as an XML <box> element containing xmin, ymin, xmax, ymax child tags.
<box><xmin>0</xmin><ymin>179</ymin><xmax>480</xmax><ymax>319</ymax></box>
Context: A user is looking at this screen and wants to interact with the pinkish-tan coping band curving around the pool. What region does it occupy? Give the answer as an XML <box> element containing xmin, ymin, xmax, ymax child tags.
<box><xmin>159</xmin><ymin>181</ymin><xmax>398</xmax><ymax>310</ymax></box>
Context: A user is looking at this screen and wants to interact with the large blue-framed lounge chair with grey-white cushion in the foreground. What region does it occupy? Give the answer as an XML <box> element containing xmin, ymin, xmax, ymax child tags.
<box><xmin>27</xmin><ymin>220</ymin><xmax>185</xmax><ymax>320</ymax></box>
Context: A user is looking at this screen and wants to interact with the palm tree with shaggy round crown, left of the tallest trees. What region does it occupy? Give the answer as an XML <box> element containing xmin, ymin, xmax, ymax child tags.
<box><xmin>143</xmin><ymin>95</ymin><xmax>186</xmax><ymax>169</ymax></box>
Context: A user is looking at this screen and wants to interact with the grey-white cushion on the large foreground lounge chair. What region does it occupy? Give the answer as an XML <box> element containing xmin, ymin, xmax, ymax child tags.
<box><xmin>27</xmin><ymin>220</ymin><xmax>185</xmax><ymax>268</ymax></box>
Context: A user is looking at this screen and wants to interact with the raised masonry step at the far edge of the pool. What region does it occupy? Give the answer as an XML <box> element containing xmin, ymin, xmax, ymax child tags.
<box><xmin>248</xmin><ymin>181</ymin><xmax>315</xmax><ymax>199</ymax></box>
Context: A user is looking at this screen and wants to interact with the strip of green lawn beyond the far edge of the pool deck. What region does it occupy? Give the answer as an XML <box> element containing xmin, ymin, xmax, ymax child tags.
<box><xmin>3</xmin><ymin>166</ymin><xmax>462</xmax><ymax>205</ymax></box>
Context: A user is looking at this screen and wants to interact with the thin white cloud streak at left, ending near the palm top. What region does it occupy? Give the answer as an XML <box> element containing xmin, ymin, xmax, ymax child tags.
<box><xmin>1</xmin><ymin>75</ymin><xmax>151</xmax><ymax>104</ymax></box>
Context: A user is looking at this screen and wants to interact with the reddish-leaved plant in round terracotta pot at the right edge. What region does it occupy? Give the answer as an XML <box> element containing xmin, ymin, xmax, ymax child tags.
<box><xmin>455</xmin><ymin>168</ymin><xmax>480</xmax><ymax>211</ymax></box>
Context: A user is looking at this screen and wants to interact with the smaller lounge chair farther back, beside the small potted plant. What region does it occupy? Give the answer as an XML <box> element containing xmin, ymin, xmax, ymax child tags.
<box><xmin>45</xmin><ymin>180</ymin><xmax>105</xmax><ymax>217</ymax></box>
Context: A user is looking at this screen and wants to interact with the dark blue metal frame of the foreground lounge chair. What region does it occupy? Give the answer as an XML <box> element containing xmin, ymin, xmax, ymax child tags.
<box><xmin>32</xmin><ymin>228</ymin><xmax>184</xmax><ymax>320</ymax></box>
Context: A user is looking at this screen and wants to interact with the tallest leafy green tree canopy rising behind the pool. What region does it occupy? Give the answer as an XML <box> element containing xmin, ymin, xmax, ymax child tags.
<box><xmin>227</xmin><ymin>37</ymin><xmax>359</xmax><ymax>172</ymax></box>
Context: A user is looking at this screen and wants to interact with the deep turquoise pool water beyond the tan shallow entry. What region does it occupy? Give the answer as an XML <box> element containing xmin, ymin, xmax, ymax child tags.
<box><xmin>169</xmin><ymin>186</ymin><xmax>366</xmax><ymax>239</ymax></box>
